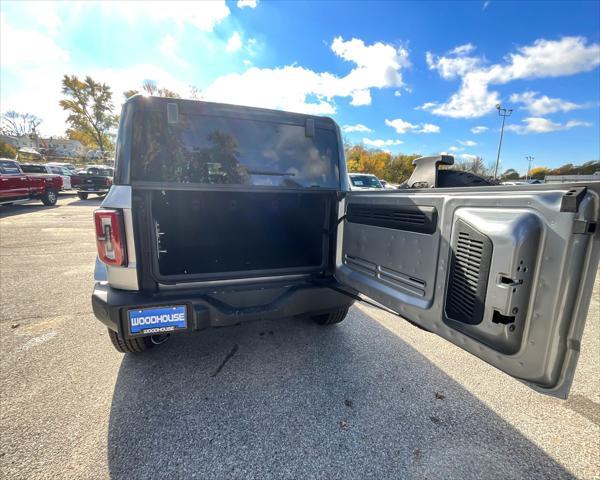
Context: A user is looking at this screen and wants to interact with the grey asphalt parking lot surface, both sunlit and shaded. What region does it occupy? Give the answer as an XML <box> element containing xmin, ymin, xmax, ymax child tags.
<box><xmin>0</xmin><ymin>197</ymin><xmax>600</xmax><ymax>479</ymax></box>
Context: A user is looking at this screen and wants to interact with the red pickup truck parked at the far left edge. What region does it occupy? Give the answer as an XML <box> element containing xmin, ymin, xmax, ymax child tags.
<box><xmin>0</xmin><ymin>158</ymin><xmax>62</xmax><ymax>205</ymax></box>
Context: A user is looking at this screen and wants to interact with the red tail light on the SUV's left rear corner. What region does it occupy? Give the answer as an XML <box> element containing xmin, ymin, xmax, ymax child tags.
<box><xmin>94</xmin><ymin>209</ymin><xmax>127</xmax><ymax>266</ymax></box>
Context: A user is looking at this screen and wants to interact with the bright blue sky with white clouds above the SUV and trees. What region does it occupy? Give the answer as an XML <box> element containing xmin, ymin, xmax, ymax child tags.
<box><xmin>0</xmin><ymin>0</ymin><xmax>600</xmax><ymax>172</ymax></box>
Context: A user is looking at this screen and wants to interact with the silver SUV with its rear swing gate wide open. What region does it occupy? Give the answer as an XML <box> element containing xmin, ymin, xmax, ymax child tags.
<box><xmin>92</xmin><ymin>96</ymin><xmax>600</xmax><ymax>398</ymax></box>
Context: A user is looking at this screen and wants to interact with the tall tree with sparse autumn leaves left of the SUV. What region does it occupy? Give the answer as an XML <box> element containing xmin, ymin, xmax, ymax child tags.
<box><xmin>60</xmin><ymin>75</ymin><xmax>118</xmax><ymax>156</ymax></box>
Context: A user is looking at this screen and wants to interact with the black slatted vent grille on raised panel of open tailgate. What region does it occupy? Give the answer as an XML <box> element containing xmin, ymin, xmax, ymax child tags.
<box><xmin>446</xmin><ymin>220</ymin><xmax>492</xmax><ymax>324</ymax></box>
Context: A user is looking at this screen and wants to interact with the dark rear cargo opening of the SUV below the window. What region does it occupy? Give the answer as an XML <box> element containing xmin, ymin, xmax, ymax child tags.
<box><xmin>147</xmin><ymin>190</ymin><xmax>336</xmax><ymax>281</ymax></box>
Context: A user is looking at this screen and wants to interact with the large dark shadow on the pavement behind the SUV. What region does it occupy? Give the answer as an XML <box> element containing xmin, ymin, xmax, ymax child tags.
<box><xmin>108</xmin><ymin>309</ymin><xmax>571</xmax><ymax>479</ymax></box>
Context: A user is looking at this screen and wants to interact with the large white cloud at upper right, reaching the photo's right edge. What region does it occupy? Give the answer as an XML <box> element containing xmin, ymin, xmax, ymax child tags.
<box><xmin>426</xmin><ymin>37</ymin><xmax>600</xmax><ymax>118</ymax></box>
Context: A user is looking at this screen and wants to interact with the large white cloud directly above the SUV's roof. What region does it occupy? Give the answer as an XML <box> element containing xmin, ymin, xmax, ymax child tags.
<box><xmin>204</xmin><ymin>37</ymin><xmax>409</xmax><ymax>115</ymax></box>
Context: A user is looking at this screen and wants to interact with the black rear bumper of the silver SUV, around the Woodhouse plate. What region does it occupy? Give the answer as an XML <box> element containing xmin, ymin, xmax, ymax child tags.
<box><xmin>92</xmin><ymin>282</ymin><xmax>354</xmax><ymax>338</ymax></box>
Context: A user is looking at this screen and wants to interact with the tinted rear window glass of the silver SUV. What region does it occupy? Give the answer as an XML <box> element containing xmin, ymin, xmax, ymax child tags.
<box><xmin>131</xmin><ymin>112</ymin><xmax>339</xmax><ymax>188</ymax></box>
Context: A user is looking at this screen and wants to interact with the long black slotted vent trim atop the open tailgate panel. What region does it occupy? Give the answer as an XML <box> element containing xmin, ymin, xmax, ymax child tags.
<box><xmin>346</xmin><ymin>203</ymin><xmax>437</xmax><ymax>234</ymax></box>
